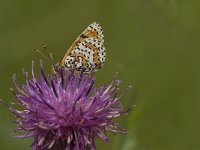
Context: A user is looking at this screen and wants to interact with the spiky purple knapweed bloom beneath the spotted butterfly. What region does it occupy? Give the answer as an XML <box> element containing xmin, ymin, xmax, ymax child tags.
<box><xmin>3</xmin><ymin>63</ymin><xmax>130</xmax><ymax>150</ymax></box>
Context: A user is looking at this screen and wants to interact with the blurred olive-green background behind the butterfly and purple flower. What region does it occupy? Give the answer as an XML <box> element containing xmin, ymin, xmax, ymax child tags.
<box><xmin>0</xmin><ymin>0</ymin><xmax>200</xmax><ymax>150</ymax></box>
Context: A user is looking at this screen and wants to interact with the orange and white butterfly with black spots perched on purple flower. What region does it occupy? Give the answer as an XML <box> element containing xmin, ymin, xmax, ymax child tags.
<box><xmin>52</xmin><ymin>22</ymin><xmax>106</xmax><ymax>73</ymax></box>
